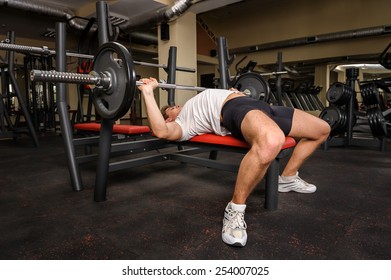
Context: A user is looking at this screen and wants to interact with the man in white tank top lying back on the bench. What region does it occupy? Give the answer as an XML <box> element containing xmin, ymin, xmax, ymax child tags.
<box><xmin>139</xmin><ymin>78</ymin><xmax>330</xmax><ymax>246</ymax></box>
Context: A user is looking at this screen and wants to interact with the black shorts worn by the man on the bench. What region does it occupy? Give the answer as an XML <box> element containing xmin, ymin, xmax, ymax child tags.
<box><xmin>221</xmin><ymin>96</ymin><xmax>294</xmax><ymax>139</ymax></box>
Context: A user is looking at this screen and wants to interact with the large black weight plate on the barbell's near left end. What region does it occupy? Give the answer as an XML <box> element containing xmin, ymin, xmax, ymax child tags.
<box><xmin>93</xmin><ymin>42</ymin><xmax>136</xmax><ymax>120</ymax></box>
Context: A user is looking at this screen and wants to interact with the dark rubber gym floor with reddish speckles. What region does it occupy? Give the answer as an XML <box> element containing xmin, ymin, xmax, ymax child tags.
<box><xmin>0</xmin><ymin>134</ymin><xmax>391</xmax><ymax>260</ymax></box>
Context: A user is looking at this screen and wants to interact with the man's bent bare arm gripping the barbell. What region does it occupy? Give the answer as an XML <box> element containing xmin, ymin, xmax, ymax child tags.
<box><xmin>139</xmin><ymin>78</ymin><xmax>182</xmax><ymax>141</ymax></box>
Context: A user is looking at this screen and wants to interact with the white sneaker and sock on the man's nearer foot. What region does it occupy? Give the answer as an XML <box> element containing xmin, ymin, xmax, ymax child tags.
<box><xmin>221</xmin><ymin>202</ymin><xmax>247</xmax><ymax>247</ymax></box>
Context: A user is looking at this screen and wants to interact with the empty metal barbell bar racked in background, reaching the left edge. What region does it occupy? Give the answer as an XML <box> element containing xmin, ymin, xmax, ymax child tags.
<box><xmin>0</xmin><ymin>42</ymin><xmax>196</xmax><ymax>73</ymax></box>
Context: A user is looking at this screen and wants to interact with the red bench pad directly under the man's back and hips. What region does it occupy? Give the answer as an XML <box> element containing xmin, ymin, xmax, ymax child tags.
<box><xmin>189</xmin><ymin>134</ymin><xmax>296</xmax><ymax>150</ymax></box>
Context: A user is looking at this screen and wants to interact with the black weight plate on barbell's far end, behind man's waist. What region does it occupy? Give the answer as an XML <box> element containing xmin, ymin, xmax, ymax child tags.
<box><xmin>233</xmin><ymin>72</ymin><xmax>270</xmax><ymax>102</ymax></box>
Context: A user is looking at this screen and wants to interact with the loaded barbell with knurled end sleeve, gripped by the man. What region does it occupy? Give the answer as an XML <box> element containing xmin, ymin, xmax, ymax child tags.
<box><xmin>30</xmin><ymin>42</ymin><xmax>272</xmax><ymax>119</ymax></box>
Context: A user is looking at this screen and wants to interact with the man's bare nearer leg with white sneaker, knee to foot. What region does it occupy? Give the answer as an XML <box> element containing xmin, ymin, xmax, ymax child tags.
<box><xmin>222</xmin><ymin>110</ymin><xmax>285</xmax><ymax>246</ymax></box>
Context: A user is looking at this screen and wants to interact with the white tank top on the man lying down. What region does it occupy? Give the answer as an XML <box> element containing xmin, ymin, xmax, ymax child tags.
<box><xmin>175</xmin><ymin>89</ymin><xmax>232</xmax><ymax>141</ymax></box>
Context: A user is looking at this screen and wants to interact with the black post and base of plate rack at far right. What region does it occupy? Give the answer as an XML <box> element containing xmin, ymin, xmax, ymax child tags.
<box><xmin>323</xmin><ymin>68</ymin><xmax>387</xmax><ymax>151</ymax></box>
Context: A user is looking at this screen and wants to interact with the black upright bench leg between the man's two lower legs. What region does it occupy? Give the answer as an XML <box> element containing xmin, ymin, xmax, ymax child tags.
<box><xmin>265</xmin><ymin>158</ymin><xmax>280</xmax><ymax>211</ymax></box>
